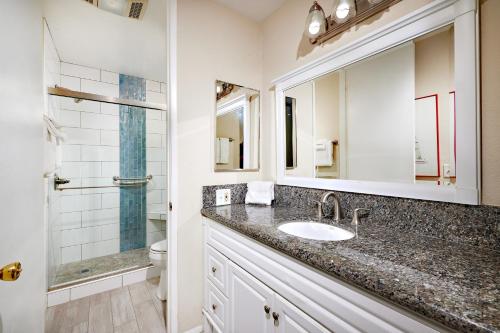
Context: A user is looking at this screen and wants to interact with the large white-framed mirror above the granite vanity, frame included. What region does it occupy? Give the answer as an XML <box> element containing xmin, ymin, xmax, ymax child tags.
<box><xmin>274</xmin><ymin>0</ymin><xmax>479</xmax><ymax>204</ymax></box>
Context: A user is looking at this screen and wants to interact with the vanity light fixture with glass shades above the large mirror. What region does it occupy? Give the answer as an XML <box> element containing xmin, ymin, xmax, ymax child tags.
<box><xmin>305</xmin><ymin>0</ymin><xmax>401</xmax><ymax>44</ymax></box>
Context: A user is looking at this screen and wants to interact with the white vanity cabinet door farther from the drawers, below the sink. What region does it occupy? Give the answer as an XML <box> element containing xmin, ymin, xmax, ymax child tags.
<box><xmin>272</xmin><ymin>294</ymin><xmax>330</xmax><ymax>333</ymax></box>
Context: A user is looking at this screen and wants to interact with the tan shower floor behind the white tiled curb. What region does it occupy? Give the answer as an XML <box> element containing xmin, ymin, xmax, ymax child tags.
<box><xmin>49</xmin><ymin>248</ymin><xmax>151</xmax><ymax>290</ymax></box>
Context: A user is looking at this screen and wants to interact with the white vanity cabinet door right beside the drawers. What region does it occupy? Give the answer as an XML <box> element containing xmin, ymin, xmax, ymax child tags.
<box><xmin>228</xmin><ymin>262</ymin><xmax>274</xmax><ymax>333</ymax></box>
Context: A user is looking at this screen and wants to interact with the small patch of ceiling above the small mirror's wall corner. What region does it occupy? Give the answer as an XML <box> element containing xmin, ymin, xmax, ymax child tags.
<box><xmin>215</xmin><ymin>0</ymin><xmax>286</xmax><ymax>22</ymax></box>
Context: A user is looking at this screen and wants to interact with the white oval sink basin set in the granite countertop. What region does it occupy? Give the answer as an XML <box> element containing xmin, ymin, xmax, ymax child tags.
<box><xmin>278</xmin><ymin>222</ymin><xmax>354</xmax><ymax>241</ymax></box>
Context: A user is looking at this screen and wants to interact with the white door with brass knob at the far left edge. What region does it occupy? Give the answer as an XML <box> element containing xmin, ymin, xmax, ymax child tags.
<box><xmin>0</xmin><ymin>0</ymin><xmax>46</xmax><ymax>333</ymax></box>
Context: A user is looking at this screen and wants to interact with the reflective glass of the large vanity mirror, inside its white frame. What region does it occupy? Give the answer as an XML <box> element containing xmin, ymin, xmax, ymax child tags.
<box><xmin>284</xmin><ymin>26</ymin><xmax>456</xmax><ymax>185</ymax></box>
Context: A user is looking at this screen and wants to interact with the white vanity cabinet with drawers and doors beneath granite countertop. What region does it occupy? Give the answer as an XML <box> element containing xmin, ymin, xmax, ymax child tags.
<box><xmin>203</xmin><ymin>218</ymin><xmax>447</xmax><ymax>333</ymax></box>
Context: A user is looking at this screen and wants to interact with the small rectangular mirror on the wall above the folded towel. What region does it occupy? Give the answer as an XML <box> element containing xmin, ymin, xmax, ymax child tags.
<box><xmin>214</xmin><ymin>81</ymin><xmax>260</xmax><ymax>171</ymax></box>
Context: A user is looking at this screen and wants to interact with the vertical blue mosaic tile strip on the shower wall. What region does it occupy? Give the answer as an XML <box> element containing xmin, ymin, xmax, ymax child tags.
<box><xmin>120</xmin><ymin>74</ymin><xmax>147</xmax><ymax>252</ymax></box>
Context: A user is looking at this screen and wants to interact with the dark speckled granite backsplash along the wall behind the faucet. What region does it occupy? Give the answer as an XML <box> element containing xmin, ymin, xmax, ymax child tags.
<box><xmin>203</xmin><ymin>184</ymin><xmax>500</xmax><ymax>251</ymax></box>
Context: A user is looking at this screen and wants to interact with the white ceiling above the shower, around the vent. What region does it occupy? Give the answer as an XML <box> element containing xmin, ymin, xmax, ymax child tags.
<box><xmin>43</xmin><ymin>0</ymin><xmax>167</xmax><ymax>82</ymax></box>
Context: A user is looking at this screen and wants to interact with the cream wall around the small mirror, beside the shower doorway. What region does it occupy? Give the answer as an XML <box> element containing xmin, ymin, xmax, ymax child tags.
<box><xmin>177</xmin><ymin>0</ymin><xmax>264</xmax><ymax>332</ymax></box>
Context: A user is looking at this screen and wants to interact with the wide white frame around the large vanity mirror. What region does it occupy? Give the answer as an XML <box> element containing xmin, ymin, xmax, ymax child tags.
<box><xmin>272</xmin><ymin>0</ymin><xmax>481</xmax><ymax>205</ymax></box>
